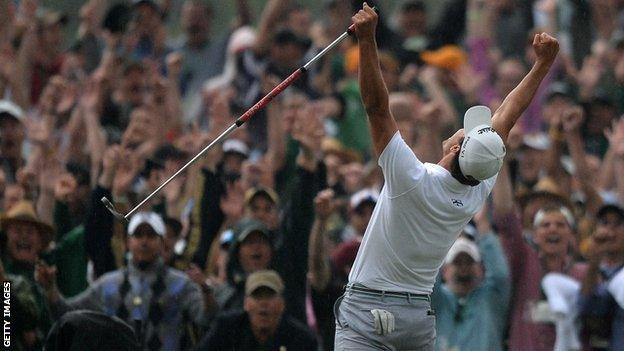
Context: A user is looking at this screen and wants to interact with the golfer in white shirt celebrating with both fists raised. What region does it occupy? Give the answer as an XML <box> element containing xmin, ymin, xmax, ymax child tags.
<box><xmin>334</xmin><ymin>3</ymin><xmax>559</xmax><ymax>350</ymax></box>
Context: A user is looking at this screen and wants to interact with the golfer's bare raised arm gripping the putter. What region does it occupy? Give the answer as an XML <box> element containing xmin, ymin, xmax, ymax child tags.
<box><xmin>352</xmin><ymin>3</ymin><xmax>398</xmax><ymax>155</ymax></box>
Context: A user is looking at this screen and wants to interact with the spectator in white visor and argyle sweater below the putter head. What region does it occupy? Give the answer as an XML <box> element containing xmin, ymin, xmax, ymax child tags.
<box><xmin>36</xmin><ymin>212</ymin><xmax>205</xmax><ymax>350</ymax></box>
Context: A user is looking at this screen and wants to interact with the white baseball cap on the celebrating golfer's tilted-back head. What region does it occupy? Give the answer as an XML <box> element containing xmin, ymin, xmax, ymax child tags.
<box><xmin>459</xmin><ymin>106</ymin><xmax>506</xmax><ymax>180</ymax></box>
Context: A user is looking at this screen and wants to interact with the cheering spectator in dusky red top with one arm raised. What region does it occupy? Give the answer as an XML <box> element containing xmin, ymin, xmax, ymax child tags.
<box><xmin>493</xmin><ymin>160</ymin><xmax>585</xmax><ymax>350</ymax></box>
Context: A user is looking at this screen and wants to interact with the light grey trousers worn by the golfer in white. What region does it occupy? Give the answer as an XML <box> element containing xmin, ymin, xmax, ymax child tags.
<box><xmin>334</xmin><ymin>289</ymin><xmax>436</xmax><ymax>351</ymax></box>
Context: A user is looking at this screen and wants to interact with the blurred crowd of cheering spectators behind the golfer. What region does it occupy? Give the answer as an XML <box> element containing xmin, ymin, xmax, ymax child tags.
<box><xmin>0</xmin><ymin>0</ymin><xmax>624</xmax><ymax>351</ymax></box>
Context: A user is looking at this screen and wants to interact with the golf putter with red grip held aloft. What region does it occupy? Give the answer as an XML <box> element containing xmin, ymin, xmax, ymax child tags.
<box><xmin>101</xmin><ymin>7</ymin><xmax>379</xmax><ymax>221</ymax></box>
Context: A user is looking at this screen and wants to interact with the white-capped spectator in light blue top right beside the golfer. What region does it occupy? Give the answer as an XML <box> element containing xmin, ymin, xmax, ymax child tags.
<box><xmin>431</xmin><ymin>207</ymin><xmax>511</xmax><ymax>351</ymax></box>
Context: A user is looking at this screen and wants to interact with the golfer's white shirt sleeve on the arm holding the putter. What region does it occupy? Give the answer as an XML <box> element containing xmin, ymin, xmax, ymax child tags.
<box><xmin>378</xmin><ymin>131</ymin><xmax>427</xmax><ymax>197</ymax></box>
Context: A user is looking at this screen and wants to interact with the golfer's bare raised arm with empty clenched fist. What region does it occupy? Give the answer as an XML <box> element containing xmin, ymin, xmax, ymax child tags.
<box><xmin>492</xmin><ymin>33</ymin><xmax>559</xmax><ymax>141</ymax></box>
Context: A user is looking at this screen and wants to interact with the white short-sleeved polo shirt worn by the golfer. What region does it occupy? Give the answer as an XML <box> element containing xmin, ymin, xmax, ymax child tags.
<box><xmin>349</xmin><ymin>132</ymin><xmax>496</xmax><ymax>294</ymax></box>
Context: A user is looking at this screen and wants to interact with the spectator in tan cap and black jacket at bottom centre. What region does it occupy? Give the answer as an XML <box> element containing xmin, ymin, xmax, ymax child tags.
<box><xmin>197</xmin><ymin>270</ymin><xmax>317</xmax><ymax>351</ymax></box>
